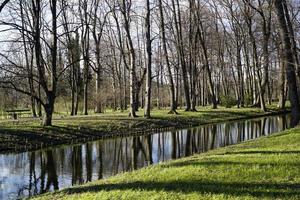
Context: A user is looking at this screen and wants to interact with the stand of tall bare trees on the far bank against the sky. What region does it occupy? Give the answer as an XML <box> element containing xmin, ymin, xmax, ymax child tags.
<box><xmin>0</xmin><ymin>0</ymin><xmax>300</xmax><ymax>125</ymax></box>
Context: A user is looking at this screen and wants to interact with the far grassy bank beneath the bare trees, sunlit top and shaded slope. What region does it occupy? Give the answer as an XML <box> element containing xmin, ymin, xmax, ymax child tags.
<box><xmin>0</xmin><ymin>107</ymin><xmax>288</xmax><ymax>152</ymax></box>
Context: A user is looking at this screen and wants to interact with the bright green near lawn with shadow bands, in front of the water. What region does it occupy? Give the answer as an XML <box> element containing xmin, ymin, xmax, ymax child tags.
<box><xmin>32</xmin><ymin>128</ymin><xmax>300</xmax><ymax>200</ymax></box>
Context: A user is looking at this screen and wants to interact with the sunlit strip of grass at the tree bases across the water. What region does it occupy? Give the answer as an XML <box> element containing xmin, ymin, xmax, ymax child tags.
<box><xmin>0</xmin><ymin>106</ymin><xmax>279</xmax><ymax>134</ymax></box>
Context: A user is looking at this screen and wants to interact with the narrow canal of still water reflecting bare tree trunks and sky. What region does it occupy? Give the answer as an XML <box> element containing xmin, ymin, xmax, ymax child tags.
<box><xmin>0</xmin><ymin>115</ymin><xmax>291</xmax><ymax>199</ymax></box>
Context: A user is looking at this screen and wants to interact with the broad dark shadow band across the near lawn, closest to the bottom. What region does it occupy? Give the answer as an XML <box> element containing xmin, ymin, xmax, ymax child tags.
<box><xmin>65</xmin><ymin>180</ymin><xmax>300</xmax><ymax>198</ymax></box>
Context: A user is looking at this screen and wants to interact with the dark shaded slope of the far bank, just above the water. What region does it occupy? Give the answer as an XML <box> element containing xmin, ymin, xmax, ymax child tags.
<box><xmin>0</xmin><ymin>109</ymin><xmax>290</xmax><ymax>154</ymax></box>
